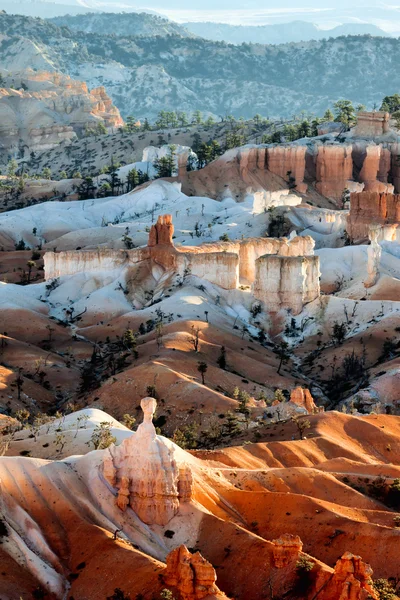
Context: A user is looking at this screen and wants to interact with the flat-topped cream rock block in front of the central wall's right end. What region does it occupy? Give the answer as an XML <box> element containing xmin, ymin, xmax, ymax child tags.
<box><xmin>253</xmin><ymin>255</ymin><xmax>320</xmax><ymax>315</ymax></box>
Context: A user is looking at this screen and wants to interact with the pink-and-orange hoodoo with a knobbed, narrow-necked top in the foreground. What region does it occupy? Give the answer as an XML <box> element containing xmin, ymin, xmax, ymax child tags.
<box><xmin>103</xmin><ymin>398</ymin><xmax>192</xmax><ymax>525</ymax></box>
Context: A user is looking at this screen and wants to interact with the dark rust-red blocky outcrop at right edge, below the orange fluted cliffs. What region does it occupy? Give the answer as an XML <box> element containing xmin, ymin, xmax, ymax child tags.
<box><xmin>347</xmin><ymin>192</ymin><xmax>400</xmax><ymax>242</ymax></box>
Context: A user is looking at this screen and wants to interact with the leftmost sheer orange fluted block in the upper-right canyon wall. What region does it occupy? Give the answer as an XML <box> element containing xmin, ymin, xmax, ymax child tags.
<box><xmin>267</xmin><ymin>146</ymin><xmax>307</xmax><ymax>194</ymax></box>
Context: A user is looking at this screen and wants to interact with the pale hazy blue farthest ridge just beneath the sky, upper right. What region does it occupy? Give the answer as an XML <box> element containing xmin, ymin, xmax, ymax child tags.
<box><xmin>183</xmin><ymin>21</ymin><xmax>390</xmax><ymax>44</ymax></box>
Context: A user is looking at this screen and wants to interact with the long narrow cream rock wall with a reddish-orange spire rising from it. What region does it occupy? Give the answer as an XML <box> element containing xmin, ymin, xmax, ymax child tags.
<box><xmin>44</xmin><ymin>215</ymin><xmax>315</xmax><ymax>298</ymax></box>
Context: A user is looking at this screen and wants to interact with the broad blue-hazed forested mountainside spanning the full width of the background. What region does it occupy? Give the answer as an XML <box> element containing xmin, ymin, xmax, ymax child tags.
<box><xmin>0</xmin><ymin>14</ymin><xmax>400</xmax><ymax>120</ymax></box>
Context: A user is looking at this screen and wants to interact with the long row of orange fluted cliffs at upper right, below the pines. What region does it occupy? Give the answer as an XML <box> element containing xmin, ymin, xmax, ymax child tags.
<box><xmin>180</xmin><ymin>134</ymin><xmax>400</xmax><ymax>207</ymax></box>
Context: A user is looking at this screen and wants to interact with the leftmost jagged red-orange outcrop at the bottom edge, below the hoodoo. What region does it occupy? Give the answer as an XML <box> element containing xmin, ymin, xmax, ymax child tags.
<box><xmin>164</xmin><ymin>545</ymin><xmax>226</xmax><ymax>600</ymax></box>
